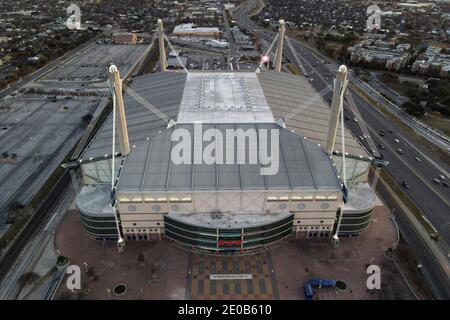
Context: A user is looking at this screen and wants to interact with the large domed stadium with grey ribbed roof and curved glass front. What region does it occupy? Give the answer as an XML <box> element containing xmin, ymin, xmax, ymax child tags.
<box><xmin>72</xmin><ymin>21</ymin><xmax>376</xmax><ymax>254</ymax></box>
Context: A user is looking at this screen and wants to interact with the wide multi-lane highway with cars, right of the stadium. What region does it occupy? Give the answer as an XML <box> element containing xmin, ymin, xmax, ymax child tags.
<box><xmin>235</xmin><ymin>1</ymin><xmax>450</xmax><ymax>298</ymax></box>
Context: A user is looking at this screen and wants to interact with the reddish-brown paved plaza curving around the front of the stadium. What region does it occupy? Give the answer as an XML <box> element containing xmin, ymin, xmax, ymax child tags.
<box><xmin>55</xmin><ymin>207</ymin><xmax>412</xmax><ymax>300</ymax></box>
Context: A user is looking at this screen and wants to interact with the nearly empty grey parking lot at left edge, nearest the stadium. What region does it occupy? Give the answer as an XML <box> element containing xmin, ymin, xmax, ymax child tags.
<box><xmin>0</xmin><ymin>96</ymin><xmax>99</xmax><ymax>224</ymax></box>
